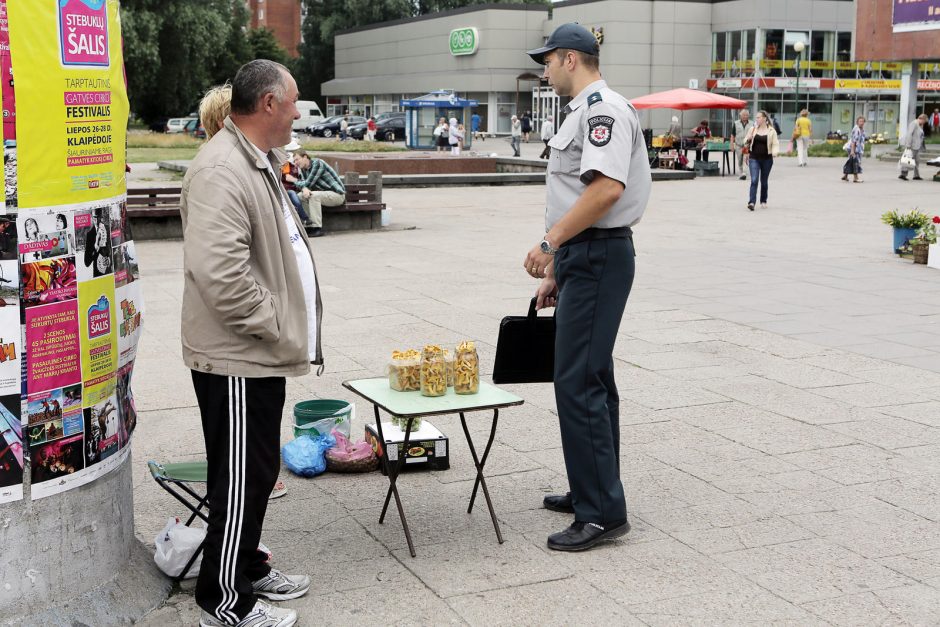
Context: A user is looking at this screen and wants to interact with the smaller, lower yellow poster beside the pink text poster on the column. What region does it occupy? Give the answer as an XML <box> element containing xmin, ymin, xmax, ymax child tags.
<box><xmin>78</xmin><ymin>274</ymin><xmax>118</xmax><ymax>407</ymax></box>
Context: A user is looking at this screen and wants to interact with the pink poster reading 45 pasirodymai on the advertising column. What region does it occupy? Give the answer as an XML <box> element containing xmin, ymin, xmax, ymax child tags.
<box><xmin>26</xmin><ymin>300</ymin><xmax>82</xmax><ymax>394</ymax></box>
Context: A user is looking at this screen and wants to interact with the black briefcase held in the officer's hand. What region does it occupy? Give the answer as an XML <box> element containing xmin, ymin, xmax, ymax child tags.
<box><xmin>493</xmin><ymin>298</ymin><xmax>555</xmax><ymax>383</ymax></box>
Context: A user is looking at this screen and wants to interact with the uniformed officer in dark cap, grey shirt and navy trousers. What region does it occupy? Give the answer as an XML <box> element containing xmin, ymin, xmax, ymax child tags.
<box><xmin>525</xmin><ymin>24</ymin><xmax>652</xmax><ymax>551</ymax></box>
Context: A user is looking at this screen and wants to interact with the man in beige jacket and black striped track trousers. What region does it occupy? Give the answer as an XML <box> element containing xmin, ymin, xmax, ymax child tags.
<box><xmin>181</xmin><ymin>60</ymin><xmax>323</xmax><ymax>627</ymax></box>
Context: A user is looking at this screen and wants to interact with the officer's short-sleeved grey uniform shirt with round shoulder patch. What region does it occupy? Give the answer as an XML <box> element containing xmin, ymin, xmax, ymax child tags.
<box><xmin>545</xmin><ymin>80</ymin><xmax>652</xmax><ymax>231</ymax></box>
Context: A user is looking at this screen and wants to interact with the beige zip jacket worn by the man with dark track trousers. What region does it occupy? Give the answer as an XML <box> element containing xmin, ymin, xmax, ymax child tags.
<box><xmin>181</xmin><ymin>118</ymin><xmax>323</xmax><ymax>377</ymax></box>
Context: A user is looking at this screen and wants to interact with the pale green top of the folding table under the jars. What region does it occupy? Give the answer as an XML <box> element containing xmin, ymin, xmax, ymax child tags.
<box><xmin>343</xmin><ymin>377</ymin><xmax>525</xmax><ymax>417</ymax></box>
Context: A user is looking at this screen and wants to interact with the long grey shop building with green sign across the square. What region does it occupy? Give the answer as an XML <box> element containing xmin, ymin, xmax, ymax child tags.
<box><xmin>323</xmin><ymin>0</ymin><xmax>940</xmax><ymax>139</ymax></box>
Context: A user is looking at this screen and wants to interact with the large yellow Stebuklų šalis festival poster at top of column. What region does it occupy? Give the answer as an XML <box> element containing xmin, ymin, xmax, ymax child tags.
<box><xmin>8</xmin><ymin>0</ymin><xmax>128</xmax><ymax>208</ymax></box>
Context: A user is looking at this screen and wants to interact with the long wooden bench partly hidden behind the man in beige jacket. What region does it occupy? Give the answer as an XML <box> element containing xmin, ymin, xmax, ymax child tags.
<box><xmin>127</xmin><ymin>171</ymin><xmax>385</xmax><ymax>240</ymax></box>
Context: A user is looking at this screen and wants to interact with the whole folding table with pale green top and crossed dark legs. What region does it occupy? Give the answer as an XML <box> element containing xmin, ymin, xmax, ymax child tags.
<box><xmin>343</xmin><ymin>377</ymin><xmax>524</xmax><ymax>557</ymax></box>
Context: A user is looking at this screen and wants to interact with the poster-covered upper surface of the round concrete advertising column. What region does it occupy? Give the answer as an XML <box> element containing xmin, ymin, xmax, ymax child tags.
<box><xmin>0</xmin><ymin>0</ymin><xmax>143</xmax><ymax>503</ymax></box>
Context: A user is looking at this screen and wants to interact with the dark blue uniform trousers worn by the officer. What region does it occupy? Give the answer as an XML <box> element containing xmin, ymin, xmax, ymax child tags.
<box><xmin>555</xmin><ymin>238</ymin><xmax>635</xmax><ymax>524</ymax></box>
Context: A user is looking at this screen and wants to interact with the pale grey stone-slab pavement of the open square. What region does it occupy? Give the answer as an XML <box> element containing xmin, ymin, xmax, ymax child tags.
<box><xmin>133</xmin><ymin>159</ymin><xmax>940</xmax><ymax>626</ymax></box>
